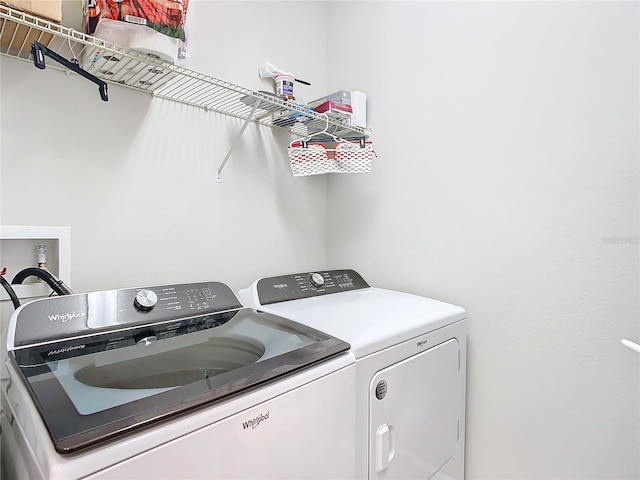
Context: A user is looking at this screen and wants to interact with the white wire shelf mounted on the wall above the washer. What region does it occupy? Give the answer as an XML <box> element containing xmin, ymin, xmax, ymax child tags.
<box><xmin>0</xmin><ymin>4</ymin><xmax>367</xmax><ymax>141</ymax></box>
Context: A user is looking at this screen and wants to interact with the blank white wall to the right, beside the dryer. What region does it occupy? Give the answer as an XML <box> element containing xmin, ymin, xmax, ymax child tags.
<box><xmin>328</xmin><ymin>2</ymin><xmax>640</xmax><ymax>479</ymax></box>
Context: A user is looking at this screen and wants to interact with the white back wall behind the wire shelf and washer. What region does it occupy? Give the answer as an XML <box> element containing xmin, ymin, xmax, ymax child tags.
<box><xmin>0</xmin><ymin>0</ymin><xmax>326</xmax><ymax>292</ymax></box>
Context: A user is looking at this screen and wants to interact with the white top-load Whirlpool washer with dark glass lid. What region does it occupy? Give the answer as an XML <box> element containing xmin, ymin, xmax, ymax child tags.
<box><xmin>1</xmin><ymin>282</ymin><xmax>355</xmax><ymax>480</ymax></box>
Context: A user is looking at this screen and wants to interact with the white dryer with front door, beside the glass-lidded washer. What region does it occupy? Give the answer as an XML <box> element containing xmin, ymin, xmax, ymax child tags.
<box><xmin>238</xmin><ymin>270</ymin><xmax>467</xmax><ymax>480</ymax></box>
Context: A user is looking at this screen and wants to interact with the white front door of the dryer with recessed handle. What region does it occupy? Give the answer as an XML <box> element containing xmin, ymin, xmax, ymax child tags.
<box><xmin>369</xmin><ymin>339</ymin><xmax>462</xmax><ymax>480</ymax></box>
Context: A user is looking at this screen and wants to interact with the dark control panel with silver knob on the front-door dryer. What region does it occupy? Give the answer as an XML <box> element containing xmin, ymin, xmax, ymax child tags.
<box><xmin>257</xmin><ymin>270</ymin><xmax>369</xmax><ymax>305</ymax></box>
